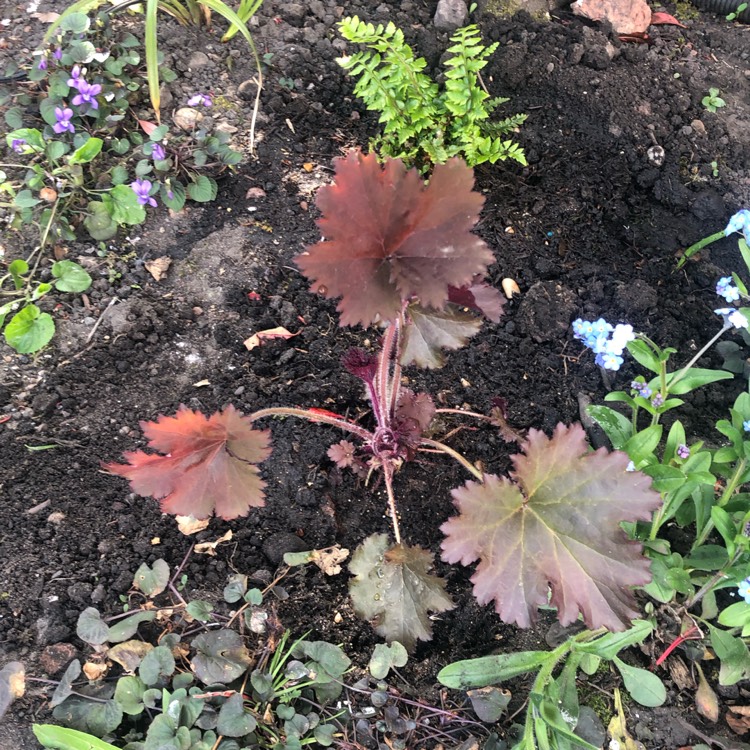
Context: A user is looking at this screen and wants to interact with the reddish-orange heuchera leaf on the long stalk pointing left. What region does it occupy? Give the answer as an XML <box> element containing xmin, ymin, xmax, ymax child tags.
<box><xmin>104</xmin><ymin>406</ymin><xmax>271</xmax><ymax>520</ymax></box>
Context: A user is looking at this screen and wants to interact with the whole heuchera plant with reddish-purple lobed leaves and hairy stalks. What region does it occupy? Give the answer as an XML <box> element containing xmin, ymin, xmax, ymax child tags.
<box><xmin>106</xmin><ymin>151</ymin><xmax>659</xmax><ymax>648</ymax></box>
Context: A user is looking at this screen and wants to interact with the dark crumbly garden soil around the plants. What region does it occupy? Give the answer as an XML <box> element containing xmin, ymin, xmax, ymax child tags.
<box><xmin>0</xmin><ymin>0</ymin><xmax>750</xmax><ymax>750</ymax></box>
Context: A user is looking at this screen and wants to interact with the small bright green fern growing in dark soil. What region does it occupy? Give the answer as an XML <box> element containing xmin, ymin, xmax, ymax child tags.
<box><xmin>337</xmin><ymin>16</ymin><xmax>526</xmax><ymax>170</ymax></box>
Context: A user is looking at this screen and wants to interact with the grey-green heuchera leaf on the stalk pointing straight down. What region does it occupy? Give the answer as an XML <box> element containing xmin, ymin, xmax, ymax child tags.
<box><xmin>349</xmin><ymin>534</ymin><xmax>454</xmax><ymax>651</ymax></box>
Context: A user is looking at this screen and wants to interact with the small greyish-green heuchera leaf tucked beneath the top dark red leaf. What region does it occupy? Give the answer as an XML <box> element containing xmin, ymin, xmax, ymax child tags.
<box><xmin>401</xmin><ymin>305</ymin><xmax>482</xmax><ymax>369</ymax></box>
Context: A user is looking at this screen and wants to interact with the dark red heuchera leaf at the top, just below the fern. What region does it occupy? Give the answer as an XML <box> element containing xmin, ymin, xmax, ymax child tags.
<box><xmin>295</xmin><ymin>151</ymin><xmax>493</xmax><ymax>325</ymax></box>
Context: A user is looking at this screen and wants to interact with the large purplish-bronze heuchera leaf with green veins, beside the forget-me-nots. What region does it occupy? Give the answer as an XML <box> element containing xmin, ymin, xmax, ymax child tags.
<box><xmin>442</xmin><ymin>424</ymin><xmax>660</xmax><ymax>630</ymax></box>
